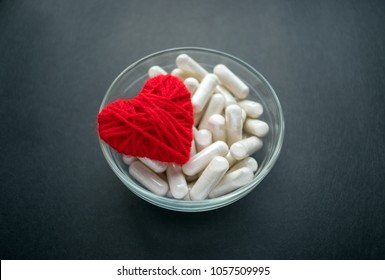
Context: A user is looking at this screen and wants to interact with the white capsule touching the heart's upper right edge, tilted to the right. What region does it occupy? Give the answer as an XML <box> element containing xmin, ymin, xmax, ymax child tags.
<box><xmin>191</xmin><ymin>74</ymin><xmax>218</xmax><ymax>113</ymax></box>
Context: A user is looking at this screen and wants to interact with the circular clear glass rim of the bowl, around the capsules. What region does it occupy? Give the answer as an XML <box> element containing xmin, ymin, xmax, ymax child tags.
<box><xmin>99</xmin><ymin>47</ymin><xmax>285</xmax><ymax>212</ymax></box>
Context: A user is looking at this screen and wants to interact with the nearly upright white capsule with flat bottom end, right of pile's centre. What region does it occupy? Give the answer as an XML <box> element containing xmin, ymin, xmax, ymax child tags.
<box><xmin>225</xmin><ymin>104</ymin><xmax>243</xmax><ymax>146</ymax></box>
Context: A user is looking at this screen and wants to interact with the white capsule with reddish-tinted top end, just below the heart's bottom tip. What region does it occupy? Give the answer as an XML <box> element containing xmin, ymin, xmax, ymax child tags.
<box><xmin>166</xmin><ymin>164</ymin><xmax>188</xmax><ymax>199</ymax></box>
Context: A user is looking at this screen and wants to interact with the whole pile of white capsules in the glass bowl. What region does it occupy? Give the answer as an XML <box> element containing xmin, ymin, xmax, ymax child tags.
<box><xmin>123</xmin><ymin>54</ymin><xmax>269</xmax><ymax>200</ymax></box>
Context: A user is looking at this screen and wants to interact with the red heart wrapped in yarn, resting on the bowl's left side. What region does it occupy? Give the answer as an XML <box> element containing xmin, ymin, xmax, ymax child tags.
<box><xmin>97</xmin><ymin>75</ymin><xmax>194</xmax><ymax>164</ymax></box>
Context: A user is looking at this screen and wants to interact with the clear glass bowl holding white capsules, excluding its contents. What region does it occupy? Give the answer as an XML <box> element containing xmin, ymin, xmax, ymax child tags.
<box><xmin>100</xmin><ymin>47</ymin><xmax>284</xmax><ymax>212</ymax></box>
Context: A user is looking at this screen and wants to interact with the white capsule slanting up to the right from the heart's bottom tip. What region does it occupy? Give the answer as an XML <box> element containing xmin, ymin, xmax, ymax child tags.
<box><xmin>182</xmin><ymin>141</ymin><xmax>229</xmax><ymax>176</ymax></box>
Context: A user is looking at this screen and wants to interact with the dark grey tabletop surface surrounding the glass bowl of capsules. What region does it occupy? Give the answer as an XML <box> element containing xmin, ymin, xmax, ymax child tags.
<box><xmin>0</xmin><ymin>0</ymin><xmax>385</xmax><ymax>259</ymax></box>
